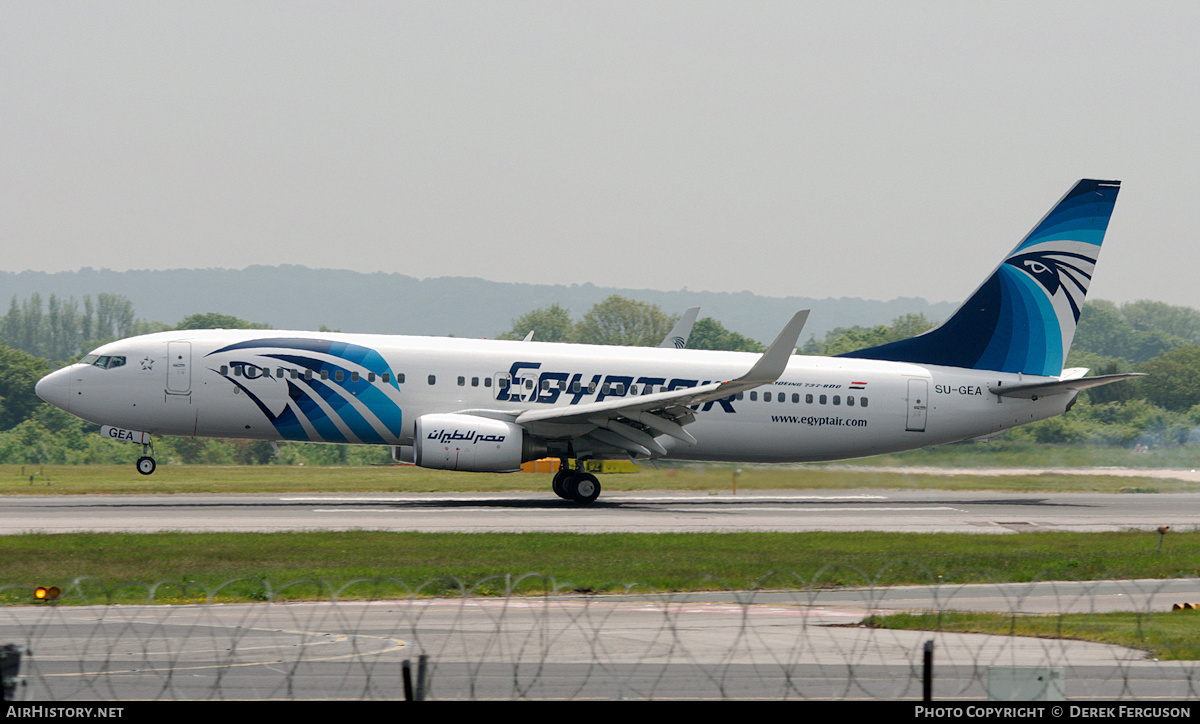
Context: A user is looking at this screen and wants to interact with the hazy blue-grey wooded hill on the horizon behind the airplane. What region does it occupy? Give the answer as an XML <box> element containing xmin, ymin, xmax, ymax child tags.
<box><xmin>0</xmin><ymin>265</ymin><xmax>955</xmax><ymax>343</ymax></box>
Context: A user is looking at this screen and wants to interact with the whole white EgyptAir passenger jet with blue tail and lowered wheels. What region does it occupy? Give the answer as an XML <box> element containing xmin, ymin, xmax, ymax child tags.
<box><xmin>36</xmin><ymin>179</ymin><xmax>1136</xmax><ymax>504</ymax></box>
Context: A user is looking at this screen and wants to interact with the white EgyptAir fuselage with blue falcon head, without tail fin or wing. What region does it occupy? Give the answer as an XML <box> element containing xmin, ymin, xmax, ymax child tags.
<box><xmin>38</xmin><ymin>330</ymin><xmax>1074</xmax><ymax>462</ymax></box>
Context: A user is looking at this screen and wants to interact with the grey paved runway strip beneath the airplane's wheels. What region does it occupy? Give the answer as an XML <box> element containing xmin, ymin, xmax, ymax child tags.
<box><xmin>0</xmin><ymin>490</ymin><xmax>1200</xmax><ymax>534</ymax></box>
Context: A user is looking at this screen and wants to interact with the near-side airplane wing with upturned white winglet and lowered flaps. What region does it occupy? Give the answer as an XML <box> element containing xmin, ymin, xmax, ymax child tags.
<box><xmin>460</xmin><ymin>310</ymin><xmax>809</xmax><ymax>457</ymax></box>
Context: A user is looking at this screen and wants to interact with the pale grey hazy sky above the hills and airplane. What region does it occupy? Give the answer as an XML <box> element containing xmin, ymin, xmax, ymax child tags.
<box><xmin>0</xmin><ymin>0</ymin><xmax>1200</xmax><ymax>307</ymax></box>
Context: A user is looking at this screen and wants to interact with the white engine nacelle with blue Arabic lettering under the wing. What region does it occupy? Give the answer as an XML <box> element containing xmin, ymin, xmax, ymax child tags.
<box><xmin>413</xmin><ymin>414</ymin><xmax>546</xmax><ymax>473</ymax></box>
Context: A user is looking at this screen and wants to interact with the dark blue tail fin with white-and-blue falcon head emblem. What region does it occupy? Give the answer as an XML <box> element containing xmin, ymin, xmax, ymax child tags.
<box><xmin>841</xmin><ymin>179</ymin><xmax>1121</xmax><ymax>376</ymax></box>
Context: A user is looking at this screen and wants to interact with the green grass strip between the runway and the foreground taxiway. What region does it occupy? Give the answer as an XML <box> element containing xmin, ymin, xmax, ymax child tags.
<box><xmin>0</xmin><ymin>531</ymin><xmax>1200</xmax><ymax>604</ymax></box>
